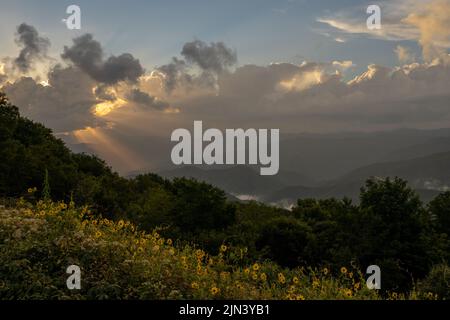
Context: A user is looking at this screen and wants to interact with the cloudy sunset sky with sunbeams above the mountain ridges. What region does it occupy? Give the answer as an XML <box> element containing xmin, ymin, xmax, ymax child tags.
<box><xmin>0</xmin><ymin>0</ymin><xmax>450</xmax><ymax>171</ymax></box>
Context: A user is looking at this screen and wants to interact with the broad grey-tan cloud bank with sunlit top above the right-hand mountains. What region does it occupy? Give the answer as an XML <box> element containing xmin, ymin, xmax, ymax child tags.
<box><xmin>170</xmin><ymin>57</ymin><xmax>450</xmax><ymax>132</ymax></box>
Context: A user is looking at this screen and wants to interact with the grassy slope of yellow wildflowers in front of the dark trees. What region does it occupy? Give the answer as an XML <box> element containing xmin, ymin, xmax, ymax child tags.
<box><xmin>0</xmin><ymin>202</ymin><xmax>437</xmax><ymax>300</ymax></box>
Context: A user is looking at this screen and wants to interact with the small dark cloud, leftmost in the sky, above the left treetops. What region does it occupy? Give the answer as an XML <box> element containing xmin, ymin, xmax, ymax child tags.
<box><xmin>14</xmin><ymin>23</ymin><xmax>50</xmax><ymax>73</ymax></box>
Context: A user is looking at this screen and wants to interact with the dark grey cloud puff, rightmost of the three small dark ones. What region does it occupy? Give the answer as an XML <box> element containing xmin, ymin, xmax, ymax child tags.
<box><xmin>181</xmin><ymin>40</ymin><xmax>237</xmax><ymax>73</ymax></box>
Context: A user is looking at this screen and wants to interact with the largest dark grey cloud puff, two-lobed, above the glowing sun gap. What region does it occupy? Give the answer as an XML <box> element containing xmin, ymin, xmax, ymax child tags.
<box><xmin>61</xmin><ymin>34</ymin><xmax>145</xmax><ymax>85</ymax></box>
